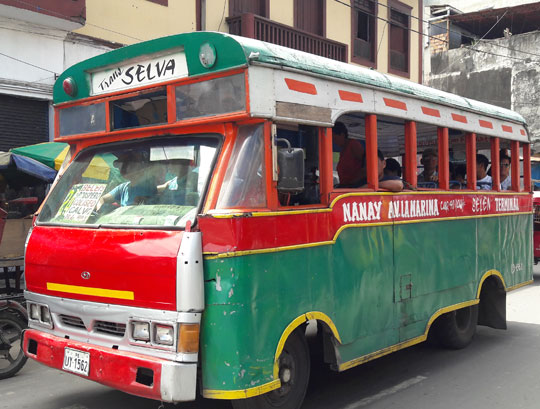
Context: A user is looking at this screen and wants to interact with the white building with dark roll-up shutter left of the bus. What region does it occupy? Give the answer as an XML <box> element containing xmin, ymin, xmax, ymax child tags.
<box><xmin>0</xmin><ymin>0</ymin><xmax>116</xmax><ymax>151</ymax></box>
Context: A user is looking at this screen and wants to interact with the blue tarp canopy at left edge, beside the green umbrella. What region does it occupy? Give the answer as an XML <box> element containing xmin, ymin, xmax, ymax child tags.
<box><xmin>0</xmin><ymin>152</ymin><xmax>56</xmax><ymax>186</ymax></box>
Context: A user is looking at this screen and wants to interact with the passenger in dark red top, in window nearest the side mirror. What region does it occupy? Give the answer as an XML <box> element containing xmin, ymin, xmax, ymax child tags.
<box><xmin>332</xmin><ymin>122</ymin><xmax>366</xmax><ymax>188</ymax></box>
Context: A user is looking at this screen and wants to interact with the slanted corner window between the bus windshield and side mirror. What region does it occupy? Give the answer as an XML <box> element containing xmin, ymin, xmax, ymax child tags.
<box><xmin>217</xmin><ymin>124</ymin><xmax>266</xmax><ymax>209</ymax></box>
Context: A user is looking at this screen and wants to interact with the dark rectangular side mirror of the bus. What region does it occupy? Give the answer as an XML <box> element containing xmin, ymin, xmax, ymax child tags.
<box><xmin>277</xmin><ymin>139</ymin><xmax>304</xmax><ymax>194</ymax></box>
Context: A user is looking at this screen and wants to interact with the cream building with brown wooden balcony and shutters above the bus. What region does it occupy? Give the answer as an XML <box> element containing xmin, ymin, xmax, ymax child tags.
<box><xmin>76</xmin><ymin>0</ymin><xmax>423</xmax><ymax>82</ymax></box>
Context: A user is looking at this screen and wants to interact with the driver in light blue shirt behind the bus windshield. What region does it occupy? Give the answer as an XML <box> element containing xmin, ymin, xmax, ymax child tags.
<box><xmin>96</xmin><ymin>152</ymin><xmax>158</xmax><ymax>211</ymax></box>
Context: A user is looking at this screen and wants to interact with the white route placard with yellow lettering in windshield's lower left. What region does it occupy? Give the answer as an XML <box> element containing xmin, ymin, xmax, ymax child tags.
<box><xmin>56</xmin><ymin>183</ymin><xmax>107</xmax><ymax>223</ymax></box>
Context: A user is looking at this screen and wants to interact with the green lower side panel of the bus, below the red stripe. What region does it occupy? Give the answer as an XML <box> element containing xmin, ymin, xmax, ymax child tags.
<box><xmin>201</xmin><ymin>215</ymin><xmax>532</xmax><ymax>391</ymax></box>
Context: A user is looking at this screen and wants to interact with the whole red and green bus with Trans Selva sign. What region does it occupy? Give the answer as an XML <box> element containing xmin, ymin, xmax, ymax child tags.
<box><xmin>24</xmin><ymin>32</ymin><xmax>533</xmax><ymax>408</ymax></box>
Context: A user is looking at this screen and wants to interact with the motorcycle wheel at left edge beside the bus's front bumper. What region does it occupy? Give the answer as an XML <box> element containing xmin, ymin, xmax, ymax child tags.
<box><xmin>0</xmin><ymin>311</ymin><xmax>27</xmax><ymax>379</ymax></box>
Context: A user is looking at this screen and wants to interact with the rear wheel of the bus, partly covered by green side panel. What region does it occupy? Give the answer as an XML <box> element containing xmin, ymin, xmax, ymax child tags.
<box><xmin>433</xmin><ymin>305</ymin><xmax>478</xmax><ymax>349</ymax></box>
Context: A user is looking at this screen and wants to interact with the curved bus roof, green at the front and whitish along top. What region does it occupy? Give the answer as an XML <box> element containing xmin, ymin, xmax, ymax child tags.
<box><xmin>54</xmin><ymin>32</ymin><xmax>525</xmax><ymax>124</ymax></box>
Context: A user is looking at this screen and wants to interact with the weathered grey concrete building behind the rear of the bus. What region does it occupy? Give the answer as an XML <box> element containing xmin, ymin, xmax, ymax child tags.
<box><xmin>424</xmin><ymin>2</ymin><xmax>540</xmax><ymax>152</ymax></box>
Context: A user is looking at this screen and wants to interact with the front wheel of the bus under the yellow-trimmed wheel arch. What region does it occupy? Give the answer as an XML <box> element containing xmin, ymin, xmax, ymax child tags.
<box><xmin>232</xmin><ymin>328</ymin><xmax>310</xmax><ymax>409</ymax></box>
